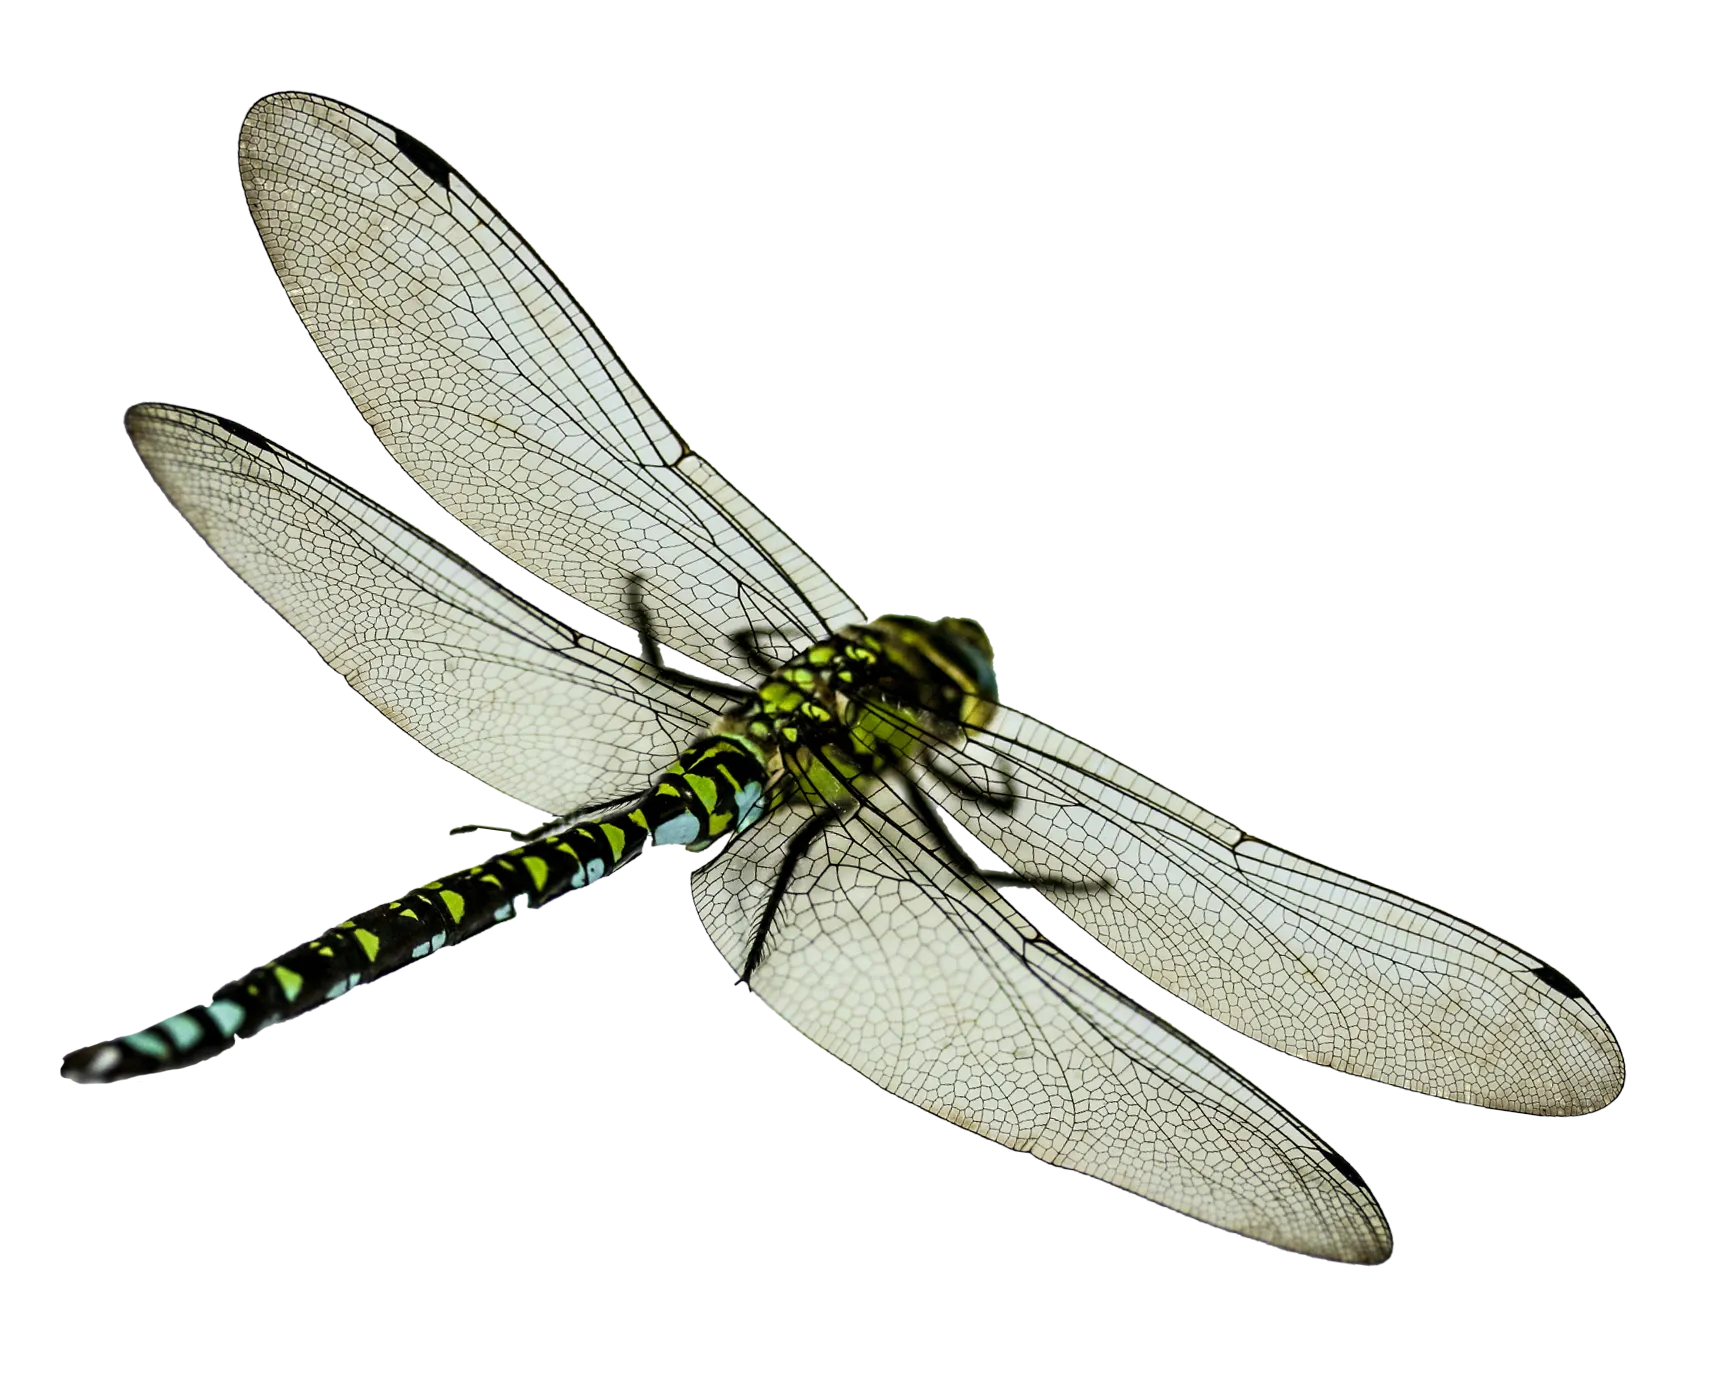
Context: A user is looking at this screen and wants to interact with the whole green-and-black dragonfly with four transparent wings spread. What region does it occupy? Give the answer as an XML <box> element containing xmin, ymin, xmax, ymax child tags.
<box><xmin>55</xmin><ymin>90</ymin><xmax>1625</xmax><ymax>1265</ymax></box>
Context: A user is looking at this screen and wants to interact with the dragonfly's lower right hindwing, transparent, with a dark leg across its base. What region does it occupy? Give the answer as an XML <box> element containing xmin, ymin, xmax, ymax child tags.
<box><xmin>691</xmin><ymin>787</ymin><xmax>1390</xmax><ymax>1264</ymax></box>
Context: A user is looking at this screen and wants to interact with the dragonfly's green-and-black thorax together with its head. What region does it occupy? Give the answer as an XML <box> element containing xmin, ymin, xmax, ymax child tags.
<box><xmin>720</xmin><ymin>615</ymin><xmax>1000</xmax><ymax>806</ymax></box>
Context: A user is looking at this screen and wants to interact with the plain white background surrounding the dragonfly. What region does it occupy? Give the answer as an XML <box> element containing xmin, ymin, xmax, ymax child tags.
<box><xmin>0</xmin><ymin>0</ymin><xmax>1727</xmax><ymax>1371</ymax></box>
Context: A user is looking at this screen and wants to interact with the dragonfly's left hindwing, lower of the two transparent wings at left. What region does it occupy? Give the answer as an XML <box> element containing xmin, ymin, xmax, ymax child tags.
<box><xmin>126</xmin><ymin>402</ymin><xmax>717</xmax><ymax>813</ymax></box>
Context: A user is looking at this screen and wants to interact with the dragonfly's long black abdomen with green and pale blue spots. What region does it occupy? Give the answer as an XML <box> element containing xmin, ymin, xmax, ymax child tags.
<box><xmin>59</xmin><ymin>735</ymin><xmax>767</xmax><ymax>1082</ymax></box>
